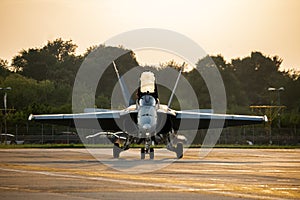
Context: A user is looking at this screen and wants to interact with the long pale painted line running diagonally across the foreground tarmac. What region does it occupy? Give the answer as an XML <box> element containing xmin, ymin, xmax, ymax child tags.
<box><xmin>0</xmin><ymin>168</ymin><xmax>284</xmax><ymax>200</ymax></box>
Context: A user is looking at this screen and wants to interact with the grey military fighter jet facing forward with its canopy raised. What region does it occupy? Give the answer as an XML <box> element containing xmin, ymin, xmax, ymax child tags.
<box><xmin>29</xmin><ymin>62</ymin><xmax>267</xmax><ymax>159</ymax></box>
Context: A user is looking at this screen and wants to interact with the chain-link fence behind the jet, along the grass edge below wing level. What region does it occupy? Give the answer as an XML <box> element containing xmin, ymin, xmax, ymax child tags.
<box><xmin>0</xmin><ymin>123</ymin><xmax>300</xmax><ymax>145</ymax></box>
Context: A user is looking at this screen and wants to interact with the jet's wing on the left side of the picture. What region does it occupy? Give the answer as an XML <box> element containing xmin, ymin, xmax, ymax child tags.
<box><xmin>28</xmin><ymin>110</ymin><xmax>136</xmax><ymax>132</ymax></box>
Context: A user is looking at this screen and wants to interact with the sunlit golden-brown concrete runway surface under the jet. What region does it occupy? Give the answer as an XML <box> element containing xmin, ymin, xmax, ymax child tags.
<box><xmin>0</xmin><ymin>149</ymin><xmax>300</xmax><ymax>200</ymax></box>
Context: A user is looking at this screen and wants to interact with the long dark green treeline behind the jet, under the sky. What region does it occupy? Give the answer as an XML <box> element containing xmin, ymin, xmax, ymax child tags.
<box><xmin>0</xmin><ymin>39</ymin><xmax>300</xmax><ymax>127</ymax></box>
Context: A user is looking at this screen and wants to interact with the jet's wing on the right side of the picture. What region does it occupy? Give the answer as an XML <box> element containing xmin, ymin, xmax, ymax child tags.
<box><xmin>172</xmin><ymin>111</ymin><xmax>267</xmax><ymax>130</ymax></box>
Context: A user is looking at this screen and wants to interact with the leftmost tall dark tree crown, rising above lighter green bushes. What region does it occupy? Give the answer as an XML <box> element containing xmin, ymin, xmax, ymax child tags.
<box><xmin>12</xmin><ymin>38</ymin><xmax>83</xmax><ymax>85</ymax></box>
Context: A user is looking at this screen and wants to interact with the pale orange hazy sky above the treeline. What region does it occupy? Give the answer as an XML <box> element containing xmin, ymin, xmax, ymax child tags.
<box><xmin>0</xmin><ymin>0</ymin><xmax>300</xmax><ymax>70</ymax></box>
